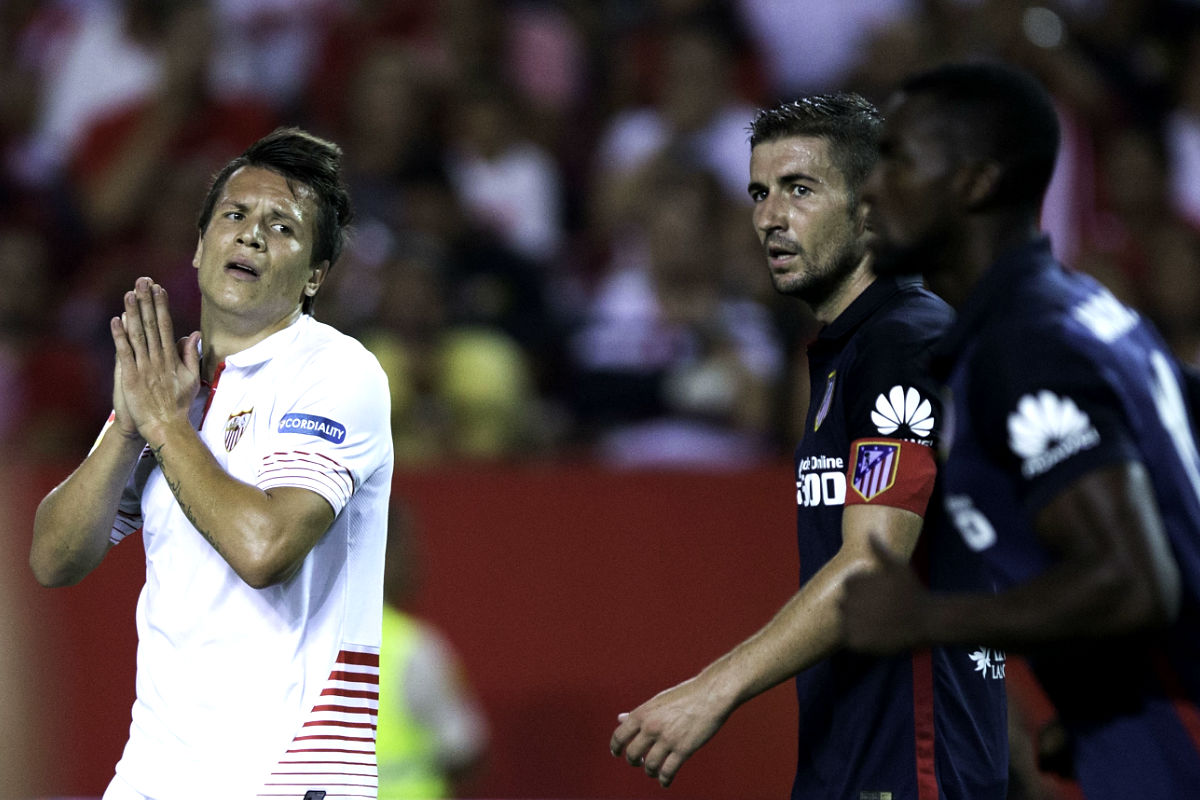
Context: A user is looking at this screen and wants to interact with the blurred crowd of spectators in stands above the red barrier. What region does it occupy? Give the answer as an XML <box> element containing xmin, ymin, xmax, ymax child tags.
<box><xmin>0</xmin><ymin>0</ymin><xmax>1200</xmax><ymax>469</ymax></box>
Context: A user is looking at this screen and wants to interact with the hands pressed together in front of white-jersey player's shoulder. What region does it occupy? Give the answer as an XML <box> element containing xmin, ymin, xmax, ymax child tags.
<box><xmin>109</xmin><ymin>277</ymin><xmax>200</xmax><ymax>440</ymax></box>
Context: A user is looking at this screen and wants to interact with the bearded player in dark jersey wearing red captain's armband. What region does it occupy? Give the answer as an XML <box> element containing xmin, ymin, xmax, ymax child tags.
<box><xmin>611</xmin><ymin>94</ymin><xmax>1008</xmax><ymax>800</ymax></box>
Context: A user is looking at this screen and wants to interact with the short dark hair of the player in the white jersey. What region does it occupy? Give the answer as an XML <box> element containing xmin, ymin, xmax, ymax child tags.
<box><xmin>198</xmin><ymin>127</ymin><xmax>354</xmax><ymax>314</ymax></box>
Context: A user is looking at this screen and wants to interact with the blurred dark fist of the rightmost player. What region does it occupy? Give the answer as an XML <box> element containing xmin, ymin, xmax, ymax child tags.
<box><xmin>841</xmin><ymin>536</ymin><xmax>928</xmax><ymax>655</ymax></box>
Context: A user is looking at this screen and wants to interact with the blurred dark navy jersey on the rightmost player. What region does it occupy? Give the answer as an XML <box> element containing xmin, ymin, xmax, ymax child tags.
<box><xmin>937</xmin><ymin>240</ymin><xmax>1200</xmax><ymax>800</ymax></box>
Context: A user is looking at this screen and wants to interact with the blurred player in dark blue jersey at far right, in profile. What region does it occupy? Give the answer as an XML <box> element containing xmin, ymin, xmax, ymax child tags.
<box><xmin>842</xmin><ymin>64</ymin><xmax>1200</xmax><ymax>800</ymax></box>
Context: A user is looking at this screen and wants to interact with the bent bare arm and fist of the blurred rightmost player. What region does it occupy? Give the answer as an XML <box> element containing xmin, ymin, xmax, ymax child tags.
<box><xmin>842</xmin><ymin>463</ymin><xmax>1180</xmax><ymax>652</ymax></box>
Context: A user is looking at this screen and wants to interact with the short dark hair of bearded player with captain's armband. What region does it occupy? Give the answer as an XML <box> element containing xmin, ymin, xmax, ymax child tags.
<box><xmin>749</xmin><ymin>91</ymin><xmax>883</xmax><ymax>203</ymax></box>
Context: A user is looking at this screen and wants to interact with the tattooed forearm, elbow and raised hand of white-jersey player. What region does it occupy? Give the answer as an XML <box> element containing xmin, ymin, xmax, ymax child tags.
<box><xmin>112</xmin><ymin>278</ymin><xmax>334</xmax><ymax>588</ymax></box>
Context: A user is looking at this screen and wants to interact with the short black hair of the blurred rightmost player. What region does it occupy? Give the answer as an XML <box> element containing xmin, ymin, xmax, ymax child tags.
<box><xmin>899</xmin><ymin>61</ymin><xmax>1060</xmax><ymax>207</ymax></box>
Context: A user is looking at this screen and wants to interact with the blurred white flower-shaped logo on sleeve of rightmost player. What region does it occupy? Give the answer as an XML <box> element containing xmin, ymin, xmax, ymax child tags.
<box><xmin>1008</xmin><ymin>390</ymin><xmax>1100</xmax><ymax>477</ymax></box>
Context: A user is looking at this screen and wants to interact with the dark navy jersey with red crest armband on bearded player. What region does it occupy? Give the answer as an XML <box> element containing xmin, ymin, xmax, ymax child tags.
<box><xmin>792</xmin><ymin>278</ymin><xmax>1008</xmax><ymax>800</ymax></box>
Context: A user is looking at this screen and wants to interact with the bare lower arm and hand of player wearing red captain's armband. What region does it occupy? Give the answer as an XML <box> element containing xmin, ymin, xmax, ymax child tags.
<box><xmin>610</xmin><ymin>505</ymin><xmax>922</xmax><ymax>787</ymax></box>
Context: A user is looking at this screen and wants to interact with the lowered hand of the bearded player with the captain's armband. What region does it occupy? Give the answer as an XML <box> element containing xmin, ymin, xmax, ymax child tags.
<box><xmin>608</xmin><ymin>678</ymin><xmax>730</xmax><ymax>787</ymax></box>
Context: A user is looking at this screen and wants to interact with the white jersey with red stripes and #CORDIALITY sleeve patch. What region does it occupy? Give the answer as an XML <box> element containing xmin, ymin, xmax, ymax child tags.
<box><xmin>105</xmin><ymin>315</ymin><xmax>392</xmax><ymax>800</ymax></box>
